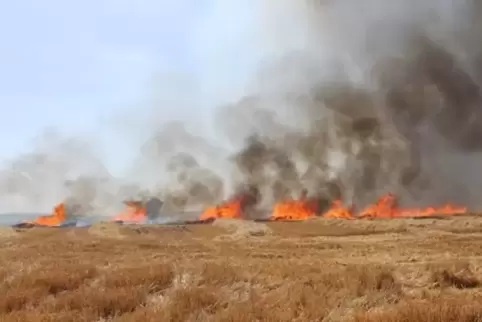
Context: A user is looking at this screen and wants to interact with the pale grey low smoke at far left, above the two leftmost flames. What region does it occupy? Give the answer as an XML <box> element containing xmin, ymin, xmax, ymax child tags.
<box><xmin>0</xmin><ymin>130</ymin><xmax>156</xmax><ymax>216</ymax></box>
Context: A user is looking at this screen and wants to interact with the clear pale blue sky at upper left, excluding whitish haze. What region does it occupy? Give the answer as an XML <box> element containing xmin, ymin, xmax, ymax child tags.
<box><xmin>0</xmin><ymin>0</ymin><xmax>256</xmax><ymax>176</ymax></box>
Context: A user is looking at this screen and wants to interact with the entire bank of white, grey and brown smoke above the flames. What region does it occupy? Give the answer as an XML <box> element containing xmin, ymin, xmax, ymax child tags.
<box><xmin>0</xmin><ymin>0</ymin><xmax>482</xmax><ymax>216</ymax></box>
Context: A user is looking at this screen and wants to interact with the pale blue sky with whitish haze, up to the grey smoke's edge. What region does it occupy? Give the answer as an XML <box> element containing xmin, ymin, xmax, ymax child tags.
<box><xmin>0</xmin><ymin>0</ymin><xmax>328</xmax><ymax>179</ymax></box>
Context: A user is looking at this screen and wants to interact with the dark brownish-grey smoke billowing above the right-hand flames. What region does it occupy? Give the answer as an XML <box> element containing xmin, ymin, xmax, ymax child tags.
<box><xmin>206</xmin><ymin>1</ymin><xmax>482</xmax><ymax>211</ymax></box>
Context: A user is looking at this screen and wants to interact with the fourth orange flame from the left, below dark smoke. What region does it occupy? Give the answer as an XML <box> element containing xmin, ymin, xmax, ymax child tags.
<box><xmin>271</xmin><ymin>198</ymin><xmax>318</xmax><ymax>221</ymax></box>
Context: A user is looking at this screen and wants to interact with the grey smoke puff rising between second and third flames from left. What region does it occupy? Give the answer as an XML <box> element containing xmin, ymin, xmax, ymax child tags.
<box><xmin>134</xmin><ymin>122</ymin><xmax>228</xmax><ymax>212</ymax></box>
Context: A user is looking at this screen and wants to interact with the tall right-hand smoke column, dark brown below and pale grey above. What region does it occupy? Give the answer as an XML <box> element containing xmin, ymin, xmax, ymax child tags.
<box><xmin>203</xmin><ymin>0</ymin><xmax>482</xmax><ymax>206</ymax></box>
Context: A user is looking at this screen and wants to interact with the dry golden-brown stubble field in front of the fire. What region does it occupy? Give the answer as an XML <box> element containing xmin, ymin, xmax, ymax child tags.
<box><xmin>0</xmin><ymin>217</ymin><xmax>482</xmax><ymax>322</ymax></box>
